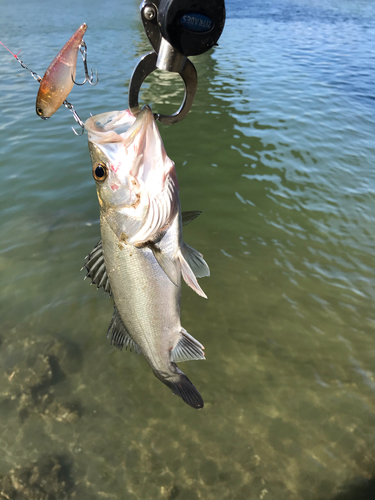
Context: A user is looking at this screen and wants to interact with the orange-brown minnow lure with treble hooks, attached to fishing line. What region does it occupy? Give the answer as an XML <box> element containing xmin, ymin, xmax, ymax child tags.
<box><xmin>0</xmin><ymin>23</ymin><xmax>98</xmax><ymax>127</ymax></box>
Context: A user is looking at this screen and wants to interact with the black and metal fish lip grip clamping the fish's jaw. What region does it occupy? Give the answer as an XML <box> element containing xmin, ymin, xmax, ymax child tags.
<box><xmin>129</xmin><ymin>0</ymin><xmax>225</xmax><ymax>125</ymax></box>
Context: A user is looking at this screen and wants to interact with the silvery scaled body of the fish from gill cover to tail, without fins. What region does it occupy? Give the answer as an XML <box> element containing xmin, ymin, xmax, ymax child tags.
<box><xmin>101</xmin><ymin>217</ymin><xmax>181</xmax><ymax>370</ymax></box>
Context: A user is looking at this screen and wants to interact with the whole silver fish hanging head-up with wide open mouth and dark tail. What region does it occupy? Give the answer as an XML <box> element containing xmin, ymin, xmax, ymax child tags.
<box><xmin>84</xmin><ymin>106</ymin><xmax>209</xmax><ymax>408</ymax></box>
